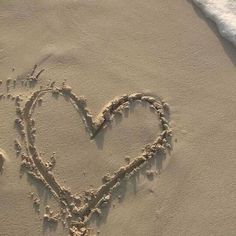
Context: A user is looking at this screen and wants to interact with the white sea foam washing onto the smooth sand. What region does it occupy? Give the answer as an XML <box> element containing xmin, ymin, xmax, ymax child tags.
<box><xmin>193</xmin><ymin>0</ymin><xmax>236</xmax><ymax>46</ymax></box>
